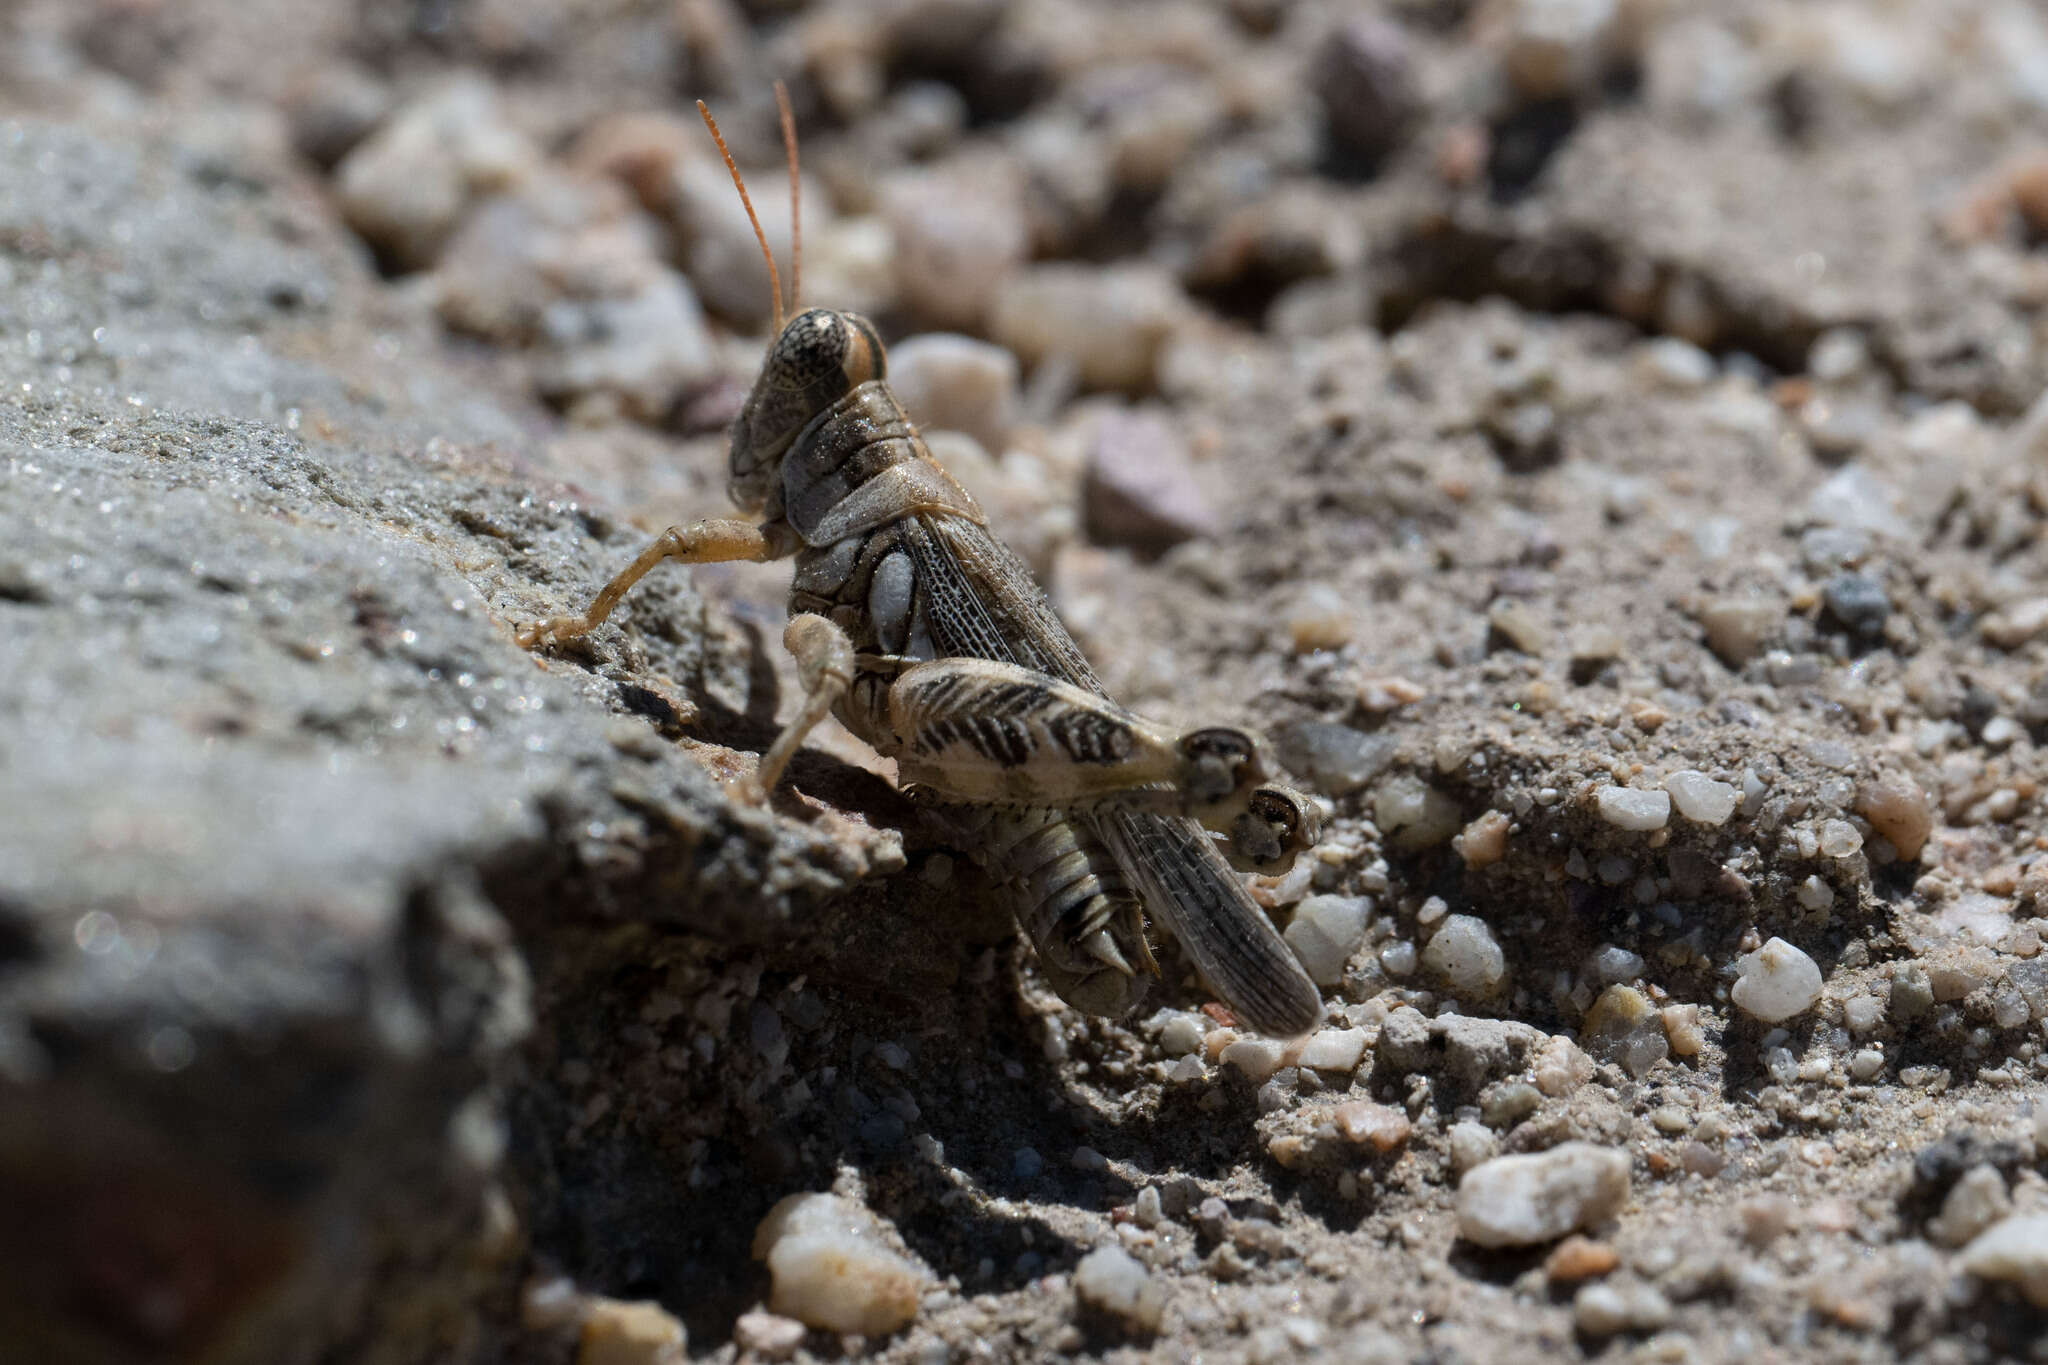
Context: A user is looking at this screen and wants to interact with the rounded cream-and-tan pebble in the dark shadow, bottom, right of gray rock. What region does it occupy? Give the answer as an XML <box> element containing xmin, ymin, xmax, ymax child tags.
<box><xmin>754</xmin><ymin>1195</ymin><xmax>929</xmax><ymax>1336</ymax></box>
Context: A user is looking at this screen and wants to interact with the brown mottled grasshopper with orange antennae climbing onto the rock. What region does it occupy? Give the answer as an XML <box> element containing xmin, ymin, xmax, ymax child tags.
<box><xmin>518</xmin><ymin>82</ymin><xmax>1321</xmax><ymax>1036</ymax></box>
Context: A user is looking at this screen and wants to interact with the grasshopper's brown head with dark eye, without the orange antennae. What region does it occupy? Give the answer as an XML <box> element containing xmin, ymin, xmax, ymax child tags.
<box><xmin>727</xmin><ymin>309</ymin><xmax>887</xmax><ymax>512</ymax></box>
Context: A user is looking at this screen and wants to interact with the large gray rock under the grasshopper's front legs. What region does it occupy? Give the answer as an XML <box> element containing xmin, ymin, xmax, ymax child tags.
<box><xmin>0</xmin><ymin>123</ymin><xmax>901</xmax><ymax>1361</ymax></box>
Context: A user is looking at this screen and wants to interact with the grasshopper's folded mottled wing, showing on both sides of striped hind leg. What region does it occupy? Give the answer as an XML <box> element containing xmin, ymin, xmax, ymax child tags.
<box><xmin>905</xmin><ymin>518</ymin><xmax>1323</xmax><ymax>1038</ymax></box>
